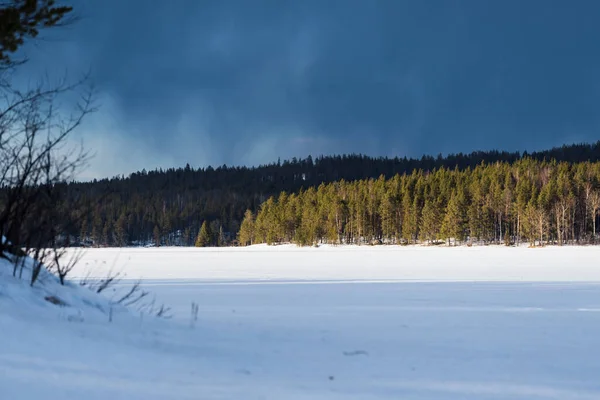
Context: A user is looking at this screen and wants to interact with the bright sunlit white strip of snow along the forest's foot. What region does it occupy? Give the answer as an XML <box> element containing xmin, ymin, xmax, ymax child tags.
<box><xmin>68</xmin><ymin>245</ymin><xmax>600</xmax><ymax>284</ymax></box>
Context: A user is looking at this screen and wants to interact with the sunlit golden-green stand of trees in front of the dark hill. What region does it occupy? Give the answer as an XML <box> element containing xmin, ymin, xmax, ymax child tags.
<box><xmin>239</xmin><ymin>158</ymin><xmax>600</xmax><ymax>245</ymax></box>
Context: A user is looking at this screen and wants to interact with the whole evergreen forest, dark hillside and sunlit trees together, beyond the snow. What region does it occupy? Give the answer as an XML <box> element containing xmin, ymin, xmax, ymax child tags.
<box><xmin>28</xmin><ymin>142</ymin><xmax>600</xmax><ymax>246</ymax></box>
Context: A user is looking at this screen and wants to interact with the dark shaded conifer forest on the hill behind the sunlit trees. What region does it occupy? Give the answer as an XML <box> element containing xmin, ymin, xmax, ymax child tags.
<box><xmin>43</xmin><ymin>142</ymin><xmax>600</xmax><ymax>246</ymax></box>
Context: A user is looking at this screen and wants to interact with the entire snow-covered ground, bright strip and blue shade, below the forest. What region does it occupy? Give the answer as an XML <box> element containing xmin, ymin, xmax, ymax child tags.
<box><xmin>0</xmin><ymin>246</ymin><xmax>600</xmax><ymax>400</ymax></box>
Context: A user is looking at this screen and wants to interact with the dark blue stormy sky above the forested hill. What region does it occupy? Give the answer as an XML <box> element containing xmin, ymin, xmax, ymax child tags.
<box><xmin>17</xmin><ymin>0</ymin><xmax>600</xmax><ymax>176</ymax></box>
